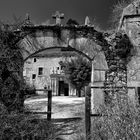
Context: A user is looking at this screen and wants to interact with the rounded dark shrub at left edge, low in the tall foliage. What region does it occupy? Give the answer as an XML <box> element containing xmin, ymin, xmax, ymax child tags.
<box><xmin>0</xmin><ymin>76</ymin><xmax>24</xmax><ymax>112</ymax></box>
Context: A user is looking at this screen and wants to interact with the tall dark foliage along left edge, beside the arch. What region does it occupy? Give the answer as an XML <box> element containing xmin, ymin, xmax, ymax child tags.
<box><xmin>0</xmin><ymin>21</ymin><xmax>29</xmax><ymax>111</ymax></box>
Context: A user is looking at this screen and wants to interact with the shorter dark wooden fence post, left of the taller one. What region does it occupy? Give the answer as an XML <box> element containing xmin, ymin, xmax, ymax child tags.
<box><xmin>47</xmin><ymin>90</ymin><xmax>52</xmax><ymax>121</ymax></box>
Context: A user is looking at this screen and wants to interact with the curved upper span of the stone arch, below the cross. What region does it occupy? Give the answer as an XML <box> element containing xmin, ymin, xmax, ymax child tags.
<box><xmin>15</xmin><ymin>13</ymin><xmax>108</xmax><ymax>114</ymax></box>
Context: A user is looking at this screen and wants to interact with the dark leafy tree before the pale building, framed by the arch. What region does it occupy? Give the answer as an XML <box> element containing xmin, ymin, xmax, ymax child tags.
<box><xmin>60</xmin><ymin>56</ymin><xmax>91</xmax><ymax>97</ymax></box>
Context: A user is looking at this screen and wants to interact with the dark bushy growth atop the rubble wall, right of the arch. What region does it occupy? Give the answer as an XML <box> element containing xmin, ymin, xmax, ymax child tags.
<box><xmin>103</xmin><ymin>32</ymin><xmax>134</xmax><ymax>61</ymax></box>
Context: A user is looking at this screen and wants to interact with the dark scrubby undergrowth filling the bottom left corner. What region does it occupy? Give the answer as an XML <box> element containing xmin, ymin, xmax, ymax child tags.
<box><xmin>0</xmin><ymin>105</ymin><xmax>57</xmax><ymax>140</ymax></box>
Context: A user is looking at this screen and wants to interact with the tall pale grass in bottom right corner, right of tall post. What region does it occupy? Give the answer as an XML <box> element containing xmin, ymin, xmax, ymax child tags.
<box><xmin>92</xmin><ymin>101</ymin><xmax>140</xmax><ymax>140</ymax></box>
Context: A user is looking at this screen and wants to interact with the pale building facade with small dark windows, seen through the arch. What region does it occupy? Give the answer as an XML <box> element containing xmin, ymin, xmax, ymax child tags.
<box><xmin>23</xmin><ymin>53</ymin><xmax>76</xmax><ymax>96</ymax></box>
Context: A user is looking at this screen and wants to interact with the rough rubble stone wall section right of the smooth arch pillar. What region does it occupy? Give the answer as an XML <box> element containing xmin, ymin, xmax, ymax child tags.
<box><xmin>104</xmin><ymin>57</ymin><xmax>128</xmax><ymax>105</ymax></box>
